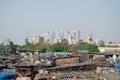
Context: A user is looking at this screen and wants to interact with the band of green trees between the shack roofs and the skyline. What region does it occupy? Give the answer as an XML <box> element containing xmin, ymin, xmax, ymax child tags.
<box><xmin>0</xmin><ymin>39</ymin><xmax>99</xmax><ymax>53</ymax></box>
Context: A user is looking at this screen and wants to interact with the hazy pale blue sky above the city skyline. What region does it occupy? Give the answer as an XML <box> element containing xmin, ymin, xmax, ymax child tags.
<box><xmin>0</xmin><ymin>0</ymin><xmax>120</xmax><ymax>42</ymax></box>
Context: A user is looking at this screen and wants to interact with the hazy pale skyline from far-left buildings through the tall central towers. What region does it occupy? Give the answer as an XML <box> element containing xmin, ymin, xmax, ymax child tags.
<box><xmin>1</xmin><ymin>29</ymin><xmax>81</xmax><ymax>44</ymax></box>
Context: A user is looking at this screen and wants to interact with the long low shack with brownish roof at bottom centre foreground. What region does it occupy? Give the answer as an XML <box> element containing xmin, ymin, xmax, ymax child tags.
<box><xmin>34</xmin><ymin>62</ymin><xmax>96</xmax><ymax>80</ymax></box>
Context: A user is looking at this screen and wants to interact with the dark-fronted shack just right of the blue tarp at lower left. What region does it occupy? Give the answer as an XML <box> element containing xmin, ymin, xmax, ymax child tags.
<box><xmin>14</xmin><ymin>61</ymin><xmax>38</xmax><ymax>80</ymax></box>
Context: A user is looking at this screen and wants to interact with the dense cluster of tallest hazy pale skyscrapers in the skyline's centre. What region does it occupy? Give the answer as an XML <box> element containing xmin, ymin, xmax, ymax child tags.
<box><xmin>44</xmin><ymin>30</ymin><xmax>80</xmax><ymax>44</ymax></box>
